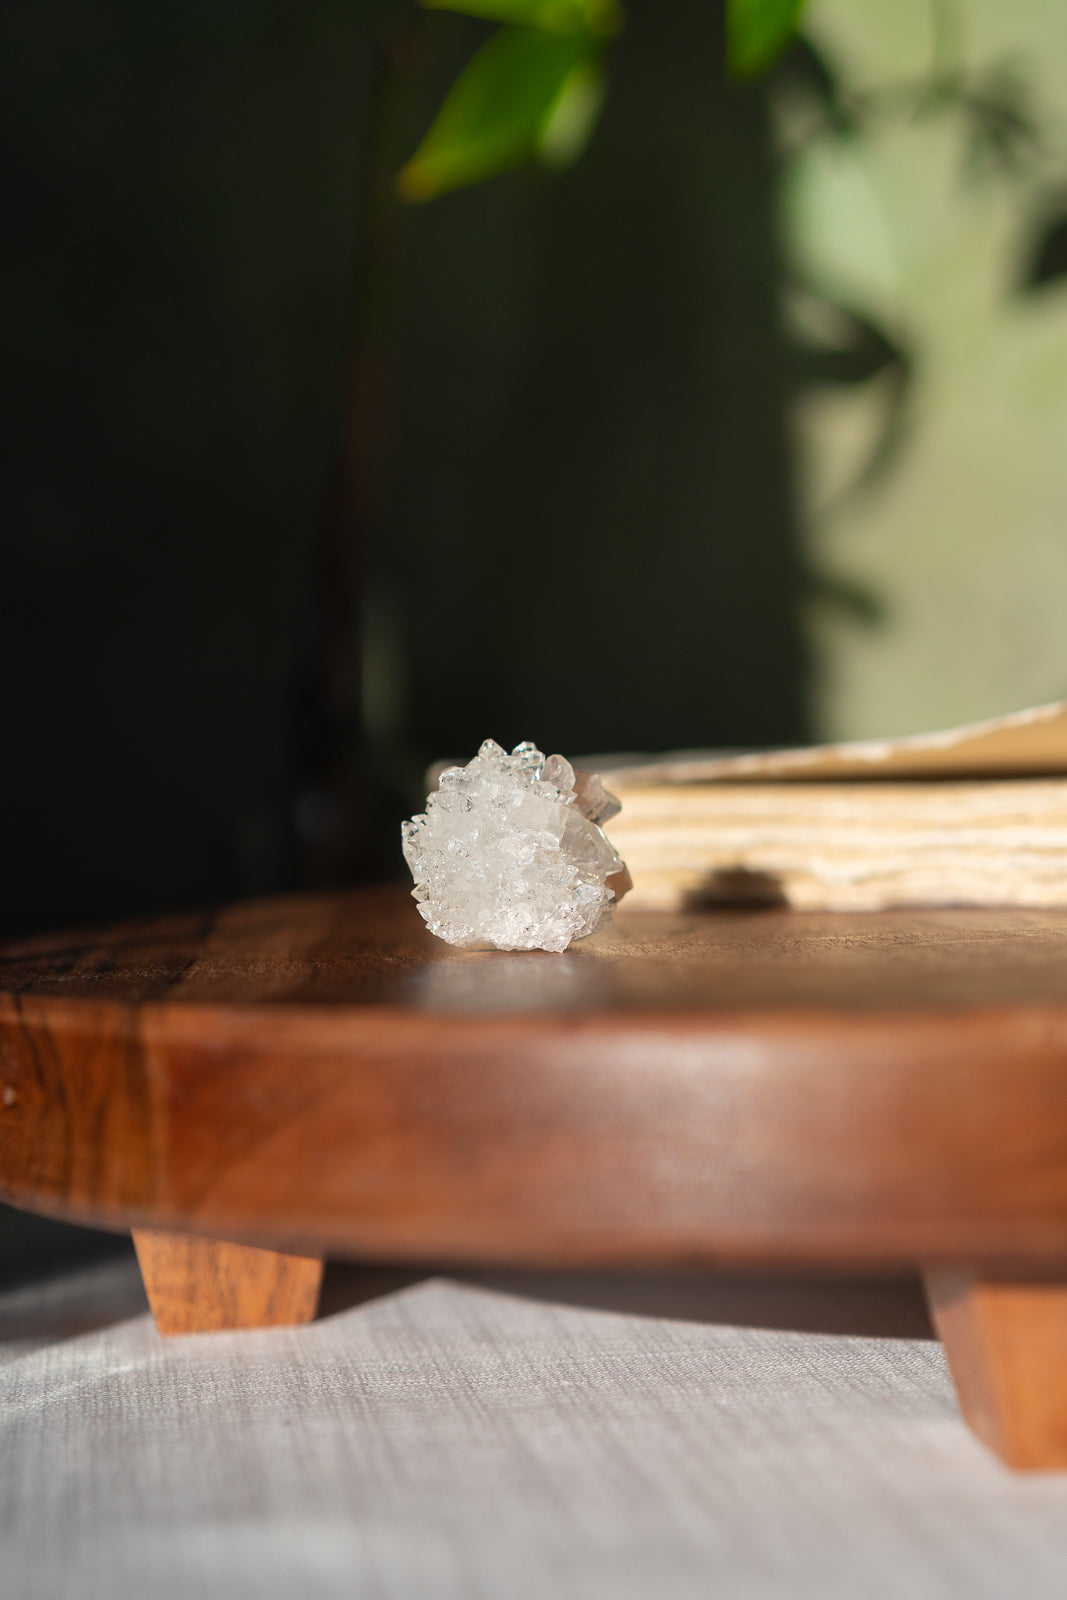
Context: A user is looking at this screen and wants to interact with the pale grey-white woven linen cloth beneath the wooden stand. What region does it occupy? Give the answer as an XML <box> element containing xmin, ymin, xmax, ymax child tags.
<box><xmin>0</xmin><ymin>1258</ymin><xmax>1067</xmax><ymax>1600</ymax></box>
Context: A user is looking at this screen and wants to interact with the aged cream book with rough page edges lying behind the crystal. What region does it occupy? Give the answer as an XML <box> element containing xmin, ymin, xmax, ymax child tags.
<box><xmin>601</xmin><ymin>701</ymin><xmax>1067</xmax><ymax>910</ymax></box>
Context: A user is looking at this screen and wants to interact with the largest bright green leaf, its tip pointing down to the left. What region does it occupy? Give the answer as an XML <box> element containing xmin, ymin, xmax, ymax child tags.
<box><xmin>397</xmin><ymin>27</ymin><xmax>598</xmax><ymax>200</ymax></box>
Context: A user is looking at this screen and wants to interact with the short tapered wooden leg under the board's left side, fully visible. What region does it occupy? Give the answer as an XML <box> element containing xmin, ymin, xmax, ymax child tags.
<box><xmin>133</xmin><ymin>1229</ymin><xmax>322</xmax><ymax>1333</ymax></box>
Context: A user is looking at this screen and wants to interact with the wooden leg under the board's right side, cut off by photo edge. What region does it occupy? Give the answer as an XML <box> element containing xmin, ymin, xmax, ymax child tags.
<box><xmin>925</xmin><ymin>1267</ymin><xmax>1067</xmax><ymax>1470</ymax></box>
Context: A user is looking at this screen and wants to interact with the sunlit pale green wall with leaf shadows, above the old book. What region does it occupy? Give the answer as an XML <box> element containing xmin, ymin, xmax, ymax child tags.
<box><xmin>781</xmin><ymin>0</ymin><xmax>1067</xmax><ymax>736</ymax></box>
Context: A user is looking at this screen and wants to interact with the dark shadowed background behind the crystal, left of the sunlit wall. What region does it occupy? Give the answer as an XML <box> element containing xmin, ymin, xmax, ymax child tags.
<box><xmin>0</xmin><ymin>0</ymin><xmax>808</xmax><ymax>1266</ymax></box>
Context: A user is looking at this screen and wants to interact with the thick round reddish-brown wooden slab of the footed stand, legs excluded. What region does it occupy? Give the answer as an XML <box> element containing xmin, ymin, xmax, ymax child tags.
<box><xmin>0</xmin><ymin>888</ymin><xmax>1067</xmax><ymax>1269</ymax></box>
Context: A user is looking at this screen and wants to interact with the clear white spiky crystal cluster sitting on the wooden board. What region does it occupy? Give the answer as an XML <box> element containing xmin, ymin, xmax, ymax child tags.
<box><xmin>403</xmin><ymin>739</ymin><xmax>629</xmax><ymax>950</ymax></box>
